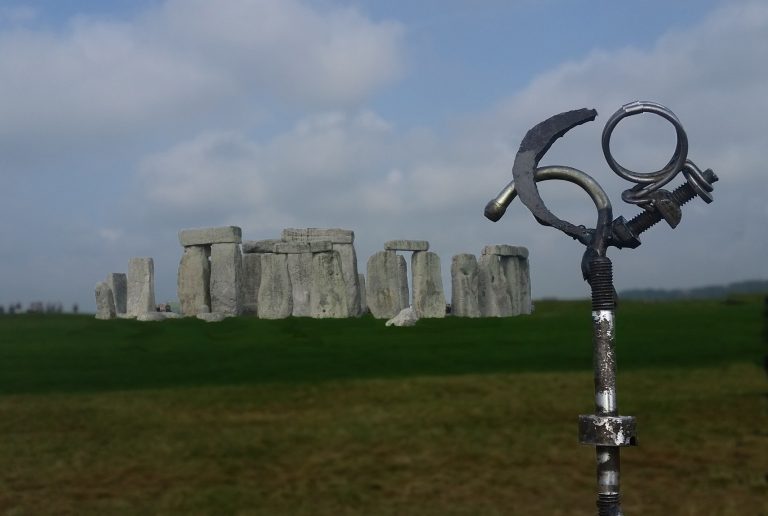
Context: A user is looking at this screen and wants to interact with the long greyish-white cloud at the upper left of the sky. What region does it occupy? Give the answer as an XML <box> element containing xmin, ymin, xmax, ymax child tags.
<box><xmin>0</xmin><ymin>0</ymin><xmax>402</xmax><ymax>145</ymax></box>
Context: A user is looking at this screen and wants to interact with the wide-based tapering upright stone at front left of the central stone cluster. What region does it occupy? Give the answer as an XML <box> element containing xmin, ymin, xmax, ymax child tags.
<box><xmin>258</xmin><ymin>254</ymin><xmax>293</xmax><ymax>319</ymax></box>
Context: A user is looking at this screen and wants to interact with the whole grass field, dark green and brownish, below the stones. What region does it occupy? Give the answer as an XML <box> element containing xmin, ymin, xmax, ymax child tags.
<box><xmin>0</xmin><ymin>298</ymin><xmax>768</xmax><ymax>516</ymax></box>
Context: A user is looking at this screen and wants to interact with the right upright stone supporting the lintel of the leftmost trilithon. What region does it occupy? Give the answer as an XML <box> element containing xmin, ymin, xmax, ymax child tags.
<box><xmin>211</xmin><ymin>244</ymin><xmax>243</xmax><ymax>315</ymax></box>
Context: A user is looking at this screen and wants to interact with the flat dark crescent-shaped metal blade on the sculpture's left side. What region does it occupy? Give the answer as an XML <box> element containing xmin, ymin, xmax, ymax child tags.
<box><xmin>512</xmin><ymin>108</ymin><xmax>597</xmax><ymax>240</ymax></box>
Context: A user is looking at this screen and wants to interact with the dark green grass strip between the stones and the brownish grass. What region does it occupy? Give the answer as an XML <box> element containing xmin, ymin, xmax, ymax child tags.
<box><xmin>0</xmin><ymin>299</ymin><xmax>763</xmax><ymax>393</ymax></box>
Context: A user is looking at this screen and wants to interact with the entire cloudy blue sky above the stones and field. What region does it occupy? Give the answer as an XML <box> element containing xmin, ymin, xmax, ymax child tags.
<box><xmin>0</xmin><ymin>0</ymin><xmax>768</xmax><ymax>311</ymax></box>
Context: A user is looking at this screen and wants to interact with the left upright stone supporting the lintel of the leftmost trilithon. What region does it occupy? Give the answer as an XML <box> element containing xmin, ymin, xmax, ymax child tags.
<box><xmin>176</xmin><ymin>245</ymin><xmax>211</xmax><ymax>316</ymax></box>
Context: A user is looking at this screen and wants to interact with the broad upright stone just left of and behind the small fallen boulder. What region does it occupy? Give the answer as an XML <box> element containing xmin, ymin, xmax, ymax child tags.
<box><xmin>366</xmin><ymin>251</ymin><xmax>405</xmax><ymax>319</ymax></box>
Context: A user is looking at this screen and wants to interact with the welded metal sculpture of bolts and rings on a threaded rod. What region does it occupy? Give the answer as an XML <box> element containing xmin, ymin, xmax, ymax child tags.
<box><xmin>485</xmin><ymin>101</ymin><xmax>718</xmax><ymax>516</ymax></box>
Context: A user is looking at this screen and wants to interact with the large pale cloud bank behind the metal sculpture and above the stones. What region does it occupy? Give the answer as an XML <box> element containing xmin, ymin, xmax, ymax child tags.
<box><xmin>138</xmin><ymin>4</ymin><xmax>768</xmax><ymax>295</ymax></box>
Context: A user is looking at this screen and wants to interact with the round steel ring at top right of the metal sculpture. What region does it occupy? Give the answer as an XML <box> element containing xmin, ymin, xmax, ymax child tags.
<box><xmin>603</xmin><ymin>101</ymin><xmax>688</xmax><ymax>185</ymax></box>
